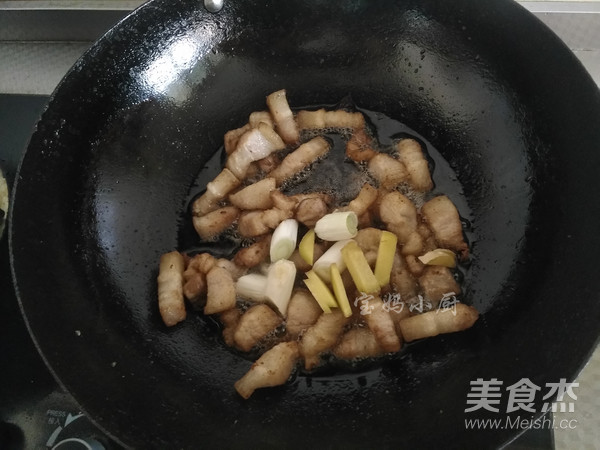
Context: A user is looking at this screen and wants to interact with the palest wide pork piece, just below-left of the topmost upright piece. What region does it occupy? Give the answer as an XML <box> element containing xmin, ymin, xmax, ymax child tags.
<box><xmin>226</xmin><ymin>122</ymin><xmax>285</xmax><ymax>180</ymax></box>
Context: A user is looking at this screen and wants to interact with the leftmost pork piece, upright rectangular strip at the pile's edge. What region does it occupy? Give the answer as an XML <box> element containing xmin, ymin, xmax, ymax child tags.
<box><xmin>157</xmin><ymin>252</ymin><xmax>186</xmax><ymax>327</ymax></box>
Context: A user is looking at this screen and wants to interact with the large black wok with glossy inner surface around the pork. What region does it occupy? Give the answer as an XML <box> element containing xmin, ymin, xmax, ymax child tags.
<box><xmin>10</xmin><ymin>0</ymin><xmax>600</xmax><ymax>448</ymax></box>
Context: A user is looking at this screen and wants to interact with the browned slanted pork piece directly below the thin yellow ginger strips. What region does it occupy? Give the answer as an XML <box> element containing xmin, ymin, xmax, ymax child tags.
<box><xmin>300</xmin><ymin>309</ymin><xmax>350</xmax><ymax>370</ymax></box>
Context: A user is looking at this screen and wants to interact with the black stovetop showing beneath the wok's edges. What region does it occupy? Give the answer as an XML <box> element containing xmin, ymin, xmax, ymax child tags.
<box><xmin>0</xmin><ymin>94</ymin><xmax>554</xmax><ymax>450</ymax></box>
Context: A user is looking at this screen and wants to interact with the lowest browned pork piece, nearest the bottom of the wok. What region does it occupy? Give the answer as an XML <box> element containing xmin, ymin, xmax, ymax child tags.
<box><xmin>234</xmin><ymin>342</ymin><xmax>299</xmax><ymax>399</ymax></box>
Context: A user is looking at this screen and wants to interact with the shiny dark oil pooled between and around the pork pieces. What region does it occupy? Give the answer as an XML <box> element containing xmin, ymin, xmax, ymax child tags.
<box><xmin>179</xmin><ymin>105</ymin><xmax>474</xmax><ymax>375</ymax></box>
